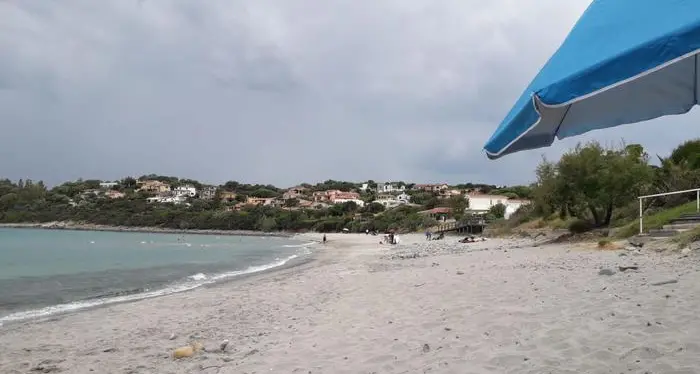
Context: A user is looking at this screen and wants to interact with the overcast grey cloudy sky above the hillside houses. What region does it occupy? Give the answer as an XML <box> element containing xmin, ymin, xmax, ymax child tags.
<box><xmin>0</xmin><ymin>0</ymin><xmax>700</xmax><ymax>186</ymax></box>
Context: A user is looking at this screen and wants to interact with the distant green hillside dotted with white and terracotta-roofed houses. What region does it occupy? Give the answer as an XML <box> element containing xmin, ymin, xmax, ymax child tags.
<box><xmin>0</xmin><ymin>175</ymin><xmax>531</xmax><ymax>232</ymax></box>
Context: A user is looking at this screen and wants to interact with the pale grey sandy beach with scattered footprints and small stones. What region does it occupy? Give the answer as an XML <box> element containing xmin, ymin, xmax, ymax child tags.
<box><xmin>0</xmin><ymin>234</ymin><xmax>700</xmax><ymax>374</ymax></box>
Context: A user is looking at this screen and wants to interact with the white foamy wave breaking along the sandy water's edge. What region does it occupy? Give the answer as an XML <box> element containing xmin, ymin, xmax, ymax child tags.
<box><xmin>0</xmin><ymin>247</ymin><xmax>311</xmax><ymax>326</ymax></box>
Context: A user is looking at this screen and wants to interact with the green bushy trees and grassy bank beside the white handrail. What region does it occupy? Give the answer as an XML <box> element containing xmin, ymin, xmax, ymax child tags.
<box><xmin>502</xmin><ymin>139</ymin><xmax>700</xmax><ymax>237</ymax></box>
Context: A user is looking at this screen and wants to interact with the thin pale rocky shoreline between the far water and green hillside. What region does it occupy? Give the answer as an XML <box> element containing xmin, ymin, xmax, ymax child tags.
<box><xmin>0</xmin><ymin>222</ymin><xmax>297</xmax><ymax>238</ymax></box>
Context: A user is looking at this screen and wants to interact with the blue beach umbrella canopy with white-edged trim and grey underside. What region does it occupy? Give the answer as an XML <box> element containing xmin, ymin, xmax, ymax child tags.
<box><xmin>484</xmin><ymin>0</ymin><xmax>700</xmax><ymax>159</ymax></box>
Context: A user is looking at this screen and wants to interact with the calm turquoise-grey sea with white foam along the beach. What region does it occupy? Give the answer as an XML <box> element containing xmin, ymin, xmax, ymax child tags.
<box><xmin>0</xmin><ymin>228</ymin><xmax>313</xmax><ymax>325</ymax></box>
